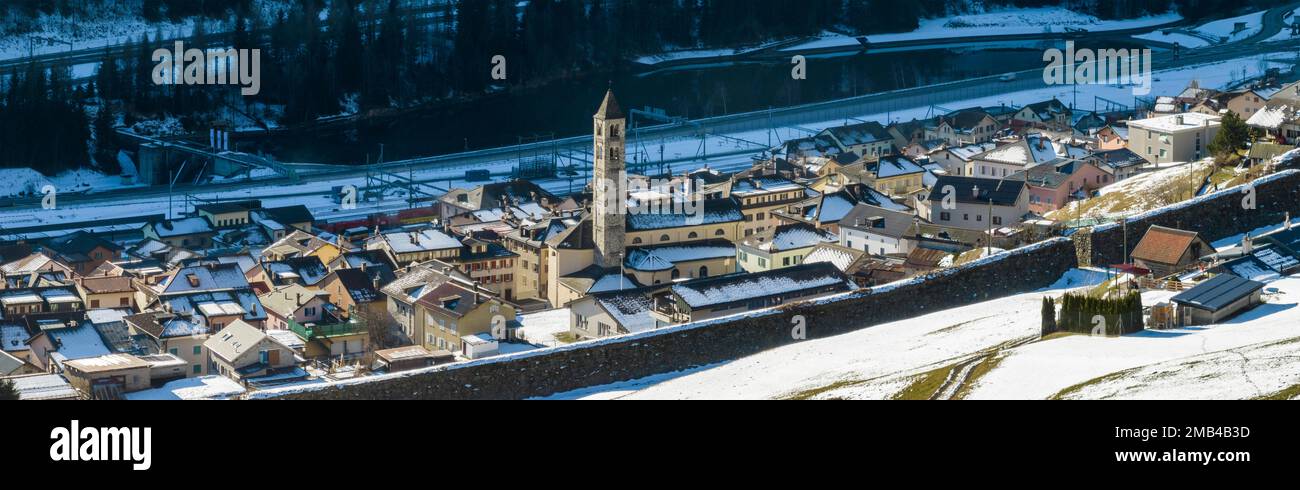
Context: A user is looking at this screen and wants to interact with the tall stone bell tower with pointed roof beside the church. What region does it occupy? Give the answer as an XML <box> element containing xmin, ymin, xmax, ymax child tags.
<box><xmin>592</xmin><ymin>88</ymin><xmax>627</xmax><ymax>268</ymax></box>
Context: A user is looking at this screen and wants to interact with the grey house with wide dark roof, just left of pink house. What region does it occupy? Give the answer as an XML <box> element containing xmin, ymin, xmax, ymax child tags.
<box><xmin>917</xmin><ymin>175</ymin><xmax>1030</xmax><ymax>230</ymax></box>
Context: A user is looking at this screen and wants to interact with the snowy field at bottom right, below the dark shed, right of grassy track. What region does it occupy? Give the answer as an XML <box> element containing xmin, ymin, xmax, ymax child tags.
<box><xmin>971</xmin><ymin>277</ymin><xmax>1300</xmax><ymax>399</ymax></box>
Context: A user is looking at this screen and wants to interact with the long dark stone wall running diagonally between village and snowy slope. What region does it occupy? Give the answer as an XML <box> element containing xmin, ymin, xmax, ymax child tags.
<box><xmin>263</xmin><ymin>172</ymin><xmax>1300</xmax><ymax>399</ymax></box>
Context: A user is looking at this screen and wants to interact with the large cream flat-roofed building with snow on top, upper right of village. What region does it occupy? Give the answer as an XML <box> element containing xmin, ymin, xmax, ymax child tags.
<box><xmin>1128</xmin><ymin>112</ymin><xmax>1219</xmax><ymax>164</ymax></box>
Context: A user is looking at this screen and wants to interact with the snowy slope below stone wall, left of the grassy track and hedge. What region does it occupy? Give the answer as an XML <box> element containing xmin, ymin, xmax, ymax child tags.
<box><xmin>543</xmin><ymin>270</ymin><xmax>1105</xmax><ymax>399</ymax></box>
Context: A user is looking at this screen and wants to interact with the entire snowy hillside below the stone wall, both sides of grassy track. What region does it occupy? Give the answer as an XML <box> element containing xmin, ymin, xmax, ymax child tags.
<box><xmin>550</xmin><ymin>265</ymin><xmax>1300</xmax><ymax>399</ymax></box>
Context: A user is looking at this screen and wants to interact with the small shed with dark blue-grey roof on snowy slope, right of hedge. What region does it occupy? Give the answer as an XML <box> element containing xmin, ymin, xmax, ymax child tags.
<box><xmin>1171</xmin><ymin>274</ymin><xmax>1264</xmax><ymax>326</ymax></box>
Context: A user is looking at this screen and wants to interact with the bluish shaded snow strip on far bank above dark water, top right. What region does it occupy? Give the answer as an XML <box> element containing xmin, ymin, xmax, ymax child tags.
<box><xmin>781</xmin><ymin>6</ymin><xmax>1183</xmax><ymax>51</ymax></box>
